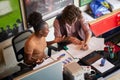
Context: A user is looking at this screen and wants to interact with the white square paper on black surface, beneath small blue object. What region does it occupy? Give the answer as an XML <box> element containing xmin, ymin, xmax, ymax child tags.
<box><xmin>92</xmin><ymin>58</ymin><xmax>115</xmax><ymax>73</ymax></box>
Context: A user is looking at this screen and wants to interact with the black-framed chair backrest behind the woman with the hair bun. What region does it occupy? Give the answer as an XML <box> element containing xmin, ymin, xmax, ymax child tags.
<box><xmin>12</xmin><ymin>30</ymin><xmax>33</xmax><ymax>62</ymax></box>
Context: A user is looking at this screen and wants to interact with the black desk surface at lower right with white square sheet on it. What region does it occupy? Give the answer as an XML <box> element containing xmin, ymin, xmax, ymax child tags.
<box><xmin>81</xmin><ymin>51</ymin><xmax>120</xmax><ymax>77</ymax></box>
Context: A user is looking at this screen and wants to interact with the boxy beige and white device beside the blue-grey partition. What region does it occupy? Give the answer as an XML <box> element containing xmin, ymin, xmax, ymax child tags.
<box><xmin>64</xmin><ymin>62</ymin><xmax>85</xmax><ymax>80</ymax></box>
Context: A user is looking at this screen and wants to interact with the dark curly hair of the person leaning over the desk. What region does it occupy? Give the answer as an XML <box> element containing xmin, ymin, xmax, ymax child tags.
<box><xmin>62</xmin><ymin>5</ymin><xmax>82</xmax><ymax>24</ymax></box>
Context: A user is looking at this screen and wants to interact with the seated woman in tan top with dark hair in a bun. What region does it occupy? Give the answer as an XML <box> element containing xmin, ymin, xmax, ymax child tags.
<box><xmin>24</xmin><ymin>12</ymin><xmax>49</xmax><ymax>65</ymax></box>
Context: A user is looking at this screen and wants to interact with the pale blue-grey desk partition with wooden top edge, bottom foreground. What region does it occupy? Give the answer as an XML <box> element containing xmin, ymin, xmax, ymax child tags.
<box><xmin>14</xmin><ymin>61</ymin><xmax>63</xmax><ymax>80</ymax></box>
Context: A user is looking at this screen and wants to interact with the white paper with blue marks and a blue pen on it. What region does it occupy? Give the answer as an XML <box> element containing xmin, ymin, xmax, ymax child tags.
<box><xmin>51</xmin><ymin>50</ymin><xmax>74</xmax><ymax>64</ymax></box>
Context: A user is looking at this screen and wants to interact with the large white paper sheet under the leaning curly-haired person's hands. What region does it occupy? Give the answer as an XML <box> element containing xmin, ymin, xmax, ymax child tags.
<box><xmin>67</xmin><ymin>37</ymin><xmax>105</xmax><ymax>59</ymax></box>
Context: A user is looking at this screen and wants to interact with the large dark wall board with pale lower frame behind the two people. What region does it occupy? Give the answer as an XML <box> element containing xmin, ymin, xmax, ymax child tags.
<box><xmin>23</xmin><ymin>0</ymin><xmax>74</xmax><ymax>27</ymax></box>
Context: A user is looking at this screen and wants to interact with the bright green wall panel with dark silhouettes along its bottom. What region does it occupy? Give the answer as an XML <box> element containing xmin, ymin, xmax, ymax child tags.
<box><xmin>0</xmin><ymin>0</ymin><xmax>24</xmax><ymax>42</ymax></box>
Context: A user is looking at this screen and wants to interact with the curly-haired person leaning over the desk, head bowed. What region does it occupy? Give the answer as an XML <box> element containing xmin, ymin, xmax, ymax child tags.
<box><xmin>53</xmin><ymin>5</ymin><xmax>92</xmax><ymax>50</ymax></box>
